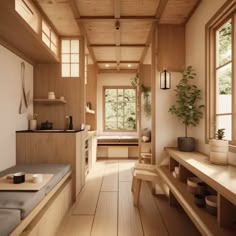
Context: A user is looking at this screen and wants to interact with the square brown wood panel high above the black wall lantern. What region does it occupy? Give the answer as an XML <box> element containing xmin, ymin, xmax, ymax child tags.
<box><xmin>157</xmin><ymin>25</ymin><xmax>185</xmax><ymax>72</ymax></box>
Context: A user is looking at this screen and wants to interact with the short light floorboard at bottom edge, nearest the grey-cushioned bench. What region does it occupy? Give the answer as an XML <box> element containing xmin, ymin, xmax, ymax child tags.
<box><xmin>57</xmin><ymin>215</ymin><xmax>93</xmax><ymax>236</ymax></box>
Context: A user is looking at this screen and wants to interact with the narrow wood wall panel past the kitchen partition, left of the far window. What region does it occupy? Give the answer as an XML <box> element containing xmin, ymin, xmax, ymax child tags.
<box><xmin>85</xmin><ymin>65</ymin><xmax>97</xmax><ymax>130</ymax></box>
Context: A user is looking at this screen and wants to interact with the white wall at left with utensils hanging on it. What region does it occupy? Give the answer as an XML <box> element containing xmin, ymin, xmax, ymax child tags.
<box><xmin>0</xmin><ymin>45</ymin><xmax>33</xmax><ymax>171</ymax></box>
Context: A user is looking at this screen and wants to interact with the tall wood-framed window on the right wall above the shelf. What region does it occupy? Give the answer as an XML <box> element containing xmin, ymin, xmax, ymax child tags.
<box><xmin>206</xmin><ymin>1</ymin><xmax>236</xmax><ymax>146</ymax></box>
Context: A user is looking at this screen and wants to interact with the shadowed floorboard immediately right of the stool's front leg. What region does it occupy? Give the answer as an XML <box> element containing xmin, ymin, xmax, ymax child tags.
<box><xmin>139</xmin><ymin>182</ymin><xmax>168</xmax><ymax>236</ymax></box>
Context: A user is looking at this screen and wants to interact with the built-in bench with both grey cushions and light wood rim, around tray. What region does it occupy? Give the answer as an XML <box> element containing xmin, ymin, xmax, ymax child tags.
<box><xmin>0</xmin><ymin>164</ymin><xmax>71</xmax><ymax>236</ymax></box>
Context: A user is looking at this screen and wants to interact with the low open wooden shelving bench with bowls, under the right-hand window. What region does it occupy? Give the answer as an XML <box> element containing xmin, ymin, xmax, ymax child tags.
<box><xmin>157</xmin><ymin>148</ymin><xmax>236</xmax><ymax>236</ymax></box>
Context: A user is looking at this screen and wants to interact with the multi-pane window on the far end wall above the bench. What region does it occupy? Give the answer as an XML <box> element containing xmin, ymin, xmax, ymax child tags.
<box><xmin>104</xmin><ymin>87</ymin><xmax>137</xmax><ymax>131</ymax></box>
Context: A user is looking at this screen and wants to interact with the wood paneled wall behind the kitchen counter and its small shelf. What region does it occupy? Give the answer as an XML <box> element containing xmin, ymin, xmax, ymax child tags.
<box><xmin>34</xmin><ymin>64</ymin><xmax>84</xmax><ymax>129</ymax></box>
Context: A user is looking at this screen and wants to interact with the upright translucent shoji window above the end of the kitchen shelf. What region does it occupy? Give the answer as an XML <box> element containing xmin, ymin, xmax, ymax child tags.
<box><xmin>61</xmin><ymin>39</ymin><xmax>79</xmax><ymax>78</ymax></box>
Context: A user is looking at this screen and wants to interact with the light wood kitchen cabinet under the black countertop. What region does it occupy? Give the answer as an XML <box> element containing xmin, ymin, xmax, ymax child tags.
<box><xmin>16</xmin><ymin>131</ymin><xmax>87</xmax><ymax>201</ymax></box>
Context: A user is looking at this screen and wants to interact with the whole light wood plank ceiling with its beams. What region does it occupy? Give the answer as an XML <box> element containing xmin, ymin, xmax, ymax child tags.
<box><xmin>34</xmin><ymin>0</ymin><xmax>200</xmax><ymax>70</ymax></box>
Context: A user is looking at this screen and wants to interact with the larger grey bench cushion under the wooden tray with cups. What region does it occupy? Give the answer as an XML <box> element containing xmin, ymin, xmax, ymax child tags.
<box><xmin>0</xmin><ymin>164</ymin><xmax>70</xmax><ymax>219</ymax></box>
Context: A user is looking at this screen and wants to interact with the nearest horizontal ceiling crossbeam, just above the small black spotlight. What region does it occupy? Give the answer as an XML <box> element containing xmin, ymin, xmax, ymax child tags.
<box><xmin>75</xmin><ymin>16</ymin><xmax>158</xmax><ymax>22</ymax></box>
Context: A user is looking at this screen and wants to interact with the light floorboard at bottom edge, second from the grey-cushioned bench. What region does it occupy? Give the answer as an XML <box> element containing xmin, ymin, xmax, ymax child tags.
<box><xmin>91</xmin><ymin>192</ymin><xmax>117</xmax><ymax>236</ymax></box>
